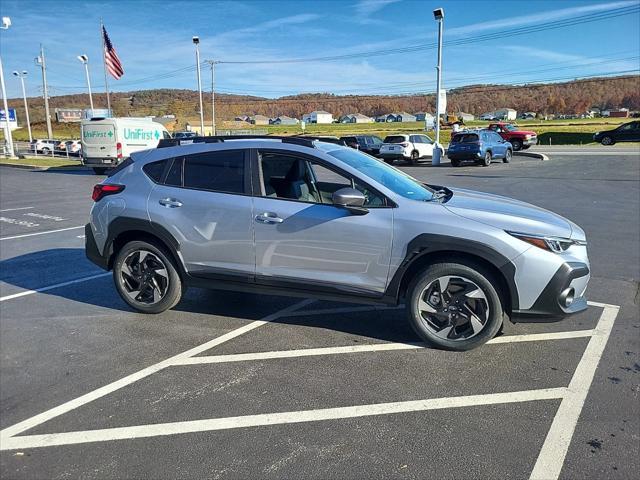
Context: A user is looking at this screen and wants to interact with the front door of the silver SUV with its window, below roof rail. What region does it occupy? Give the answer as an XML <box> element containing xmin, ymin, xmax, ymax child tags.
<box><xmin>254</xmin><ymin>150</ymin><xmax>393</xmax><ymax>295</ymax></box>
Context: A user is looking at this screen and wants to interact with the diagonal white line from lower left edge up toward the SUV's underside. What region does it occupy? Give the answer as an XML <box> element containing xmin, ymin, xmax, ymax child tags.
<box><xmin>0</xmin><ymin>300</ymin><xmax>314</xmax><ymax>442</ymax></box>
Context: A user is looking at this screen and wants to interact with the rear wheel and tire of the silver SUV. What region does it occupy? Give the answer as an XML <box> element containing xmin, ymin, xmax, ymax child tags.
<box><xmin>113</xmin><ymin>240</ymin><xmax>183</xmax><ymax>313</ymax></box>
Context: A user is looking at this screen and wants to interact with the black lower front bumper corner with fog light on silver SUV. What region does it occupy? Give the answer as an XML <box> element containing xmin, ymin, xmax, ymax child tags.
<box><xmin>512</xmin><ymin>262</ymin><xmax>590</xmax><ymax>322</ymax></box>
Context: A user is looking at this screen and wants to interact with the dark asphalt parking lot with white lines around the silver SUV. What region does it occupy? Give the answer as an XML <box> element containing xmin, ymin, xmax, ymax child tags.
<box><xmin>0</xmin><ymin>148</ymin><xmax>640</xmax><ymax>479</ymax></box>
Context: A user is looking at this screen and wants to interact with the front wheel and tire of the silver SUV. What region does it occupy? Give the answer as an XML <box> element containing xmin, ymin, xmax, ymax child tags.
<box><xmin>406</xmin><ymin>263</ymin><xmax>504</xmax><ymax>351</ymax></box>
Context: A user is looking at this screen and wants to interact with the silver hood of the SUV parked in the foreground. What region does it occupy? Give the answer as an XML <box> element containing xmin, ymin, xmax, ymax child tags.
<box><xmin>444</xmin><ymin>189</ymin><xmax>581</xmax><ymax>238</ymax></box>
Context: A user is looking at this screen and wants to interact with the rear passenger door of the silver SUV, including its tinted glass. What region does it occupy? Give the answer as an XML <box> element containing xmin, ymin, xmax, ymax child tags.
<box><xmin>147</xmin><ymin>149</ymin><xmax>255</xmax><ymax>281</ymax></box>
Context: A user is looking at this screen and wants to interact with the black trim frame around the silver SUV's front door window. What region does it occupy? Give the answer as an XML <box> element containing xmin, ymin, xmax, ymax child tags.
<box><xmin>251</xmin><ymin>147</ymin><xmax>398</xmax><ymax>209</ymax></box>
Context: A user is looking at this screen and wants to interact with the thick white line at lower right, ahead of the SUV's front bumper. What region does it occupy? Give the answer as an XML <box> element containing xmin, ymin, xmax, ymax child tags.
<box><xmin>530</xmin><ymin>305</ymin><xmax>620</xmax><ymax>480</ymax></box>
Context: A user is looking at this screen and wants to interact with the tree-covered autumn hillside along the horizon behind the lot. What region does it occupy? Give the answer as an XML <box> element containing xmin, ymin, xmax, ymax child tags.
<box><xmin>9</xmin><ymin>76</ymin><xmax>640</xmax><ymax>128</ymax></box>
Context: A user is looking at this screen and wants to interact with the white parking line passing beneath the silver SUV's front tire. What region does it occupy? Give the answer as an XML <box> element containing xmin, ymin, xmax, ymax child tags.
<box><xmin>174</xmin><ymin>330</ymin><xmax>594</xmax><ymax>365</ymax></box>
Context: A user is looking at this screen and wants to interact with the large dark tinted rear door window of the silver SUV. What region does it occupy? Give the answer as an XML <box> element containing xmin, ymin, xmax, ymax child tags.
<box><xmin>183</xmin><ymin>150</ymin><xmax>245</xmax><ymax>193</ymax></box>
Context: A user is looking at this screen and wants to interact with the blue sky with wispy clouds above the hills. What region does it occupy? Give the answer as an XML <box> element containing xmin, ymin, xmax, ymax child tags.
<box><xmin>0</xmin><ymin>0</ymin><xmax>640</xmax><ymax>97</ymax></box>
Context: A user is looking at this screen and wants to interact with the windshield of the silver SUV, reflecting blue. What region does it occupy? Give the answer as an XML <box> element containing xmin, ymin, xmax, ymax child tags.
<box><xmin>318</xmin><ymin>144</ymin><xmax>433</xmax><ymax>202</ymax></box>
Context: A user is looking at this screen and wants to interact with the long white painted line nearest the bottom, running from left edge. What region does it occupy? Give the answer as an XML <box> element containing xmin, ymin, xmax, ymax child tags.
<box><xmin>0</xmin><ymin>388</ymin><xmax>567</xmax><ymax>450</ymax></box>
